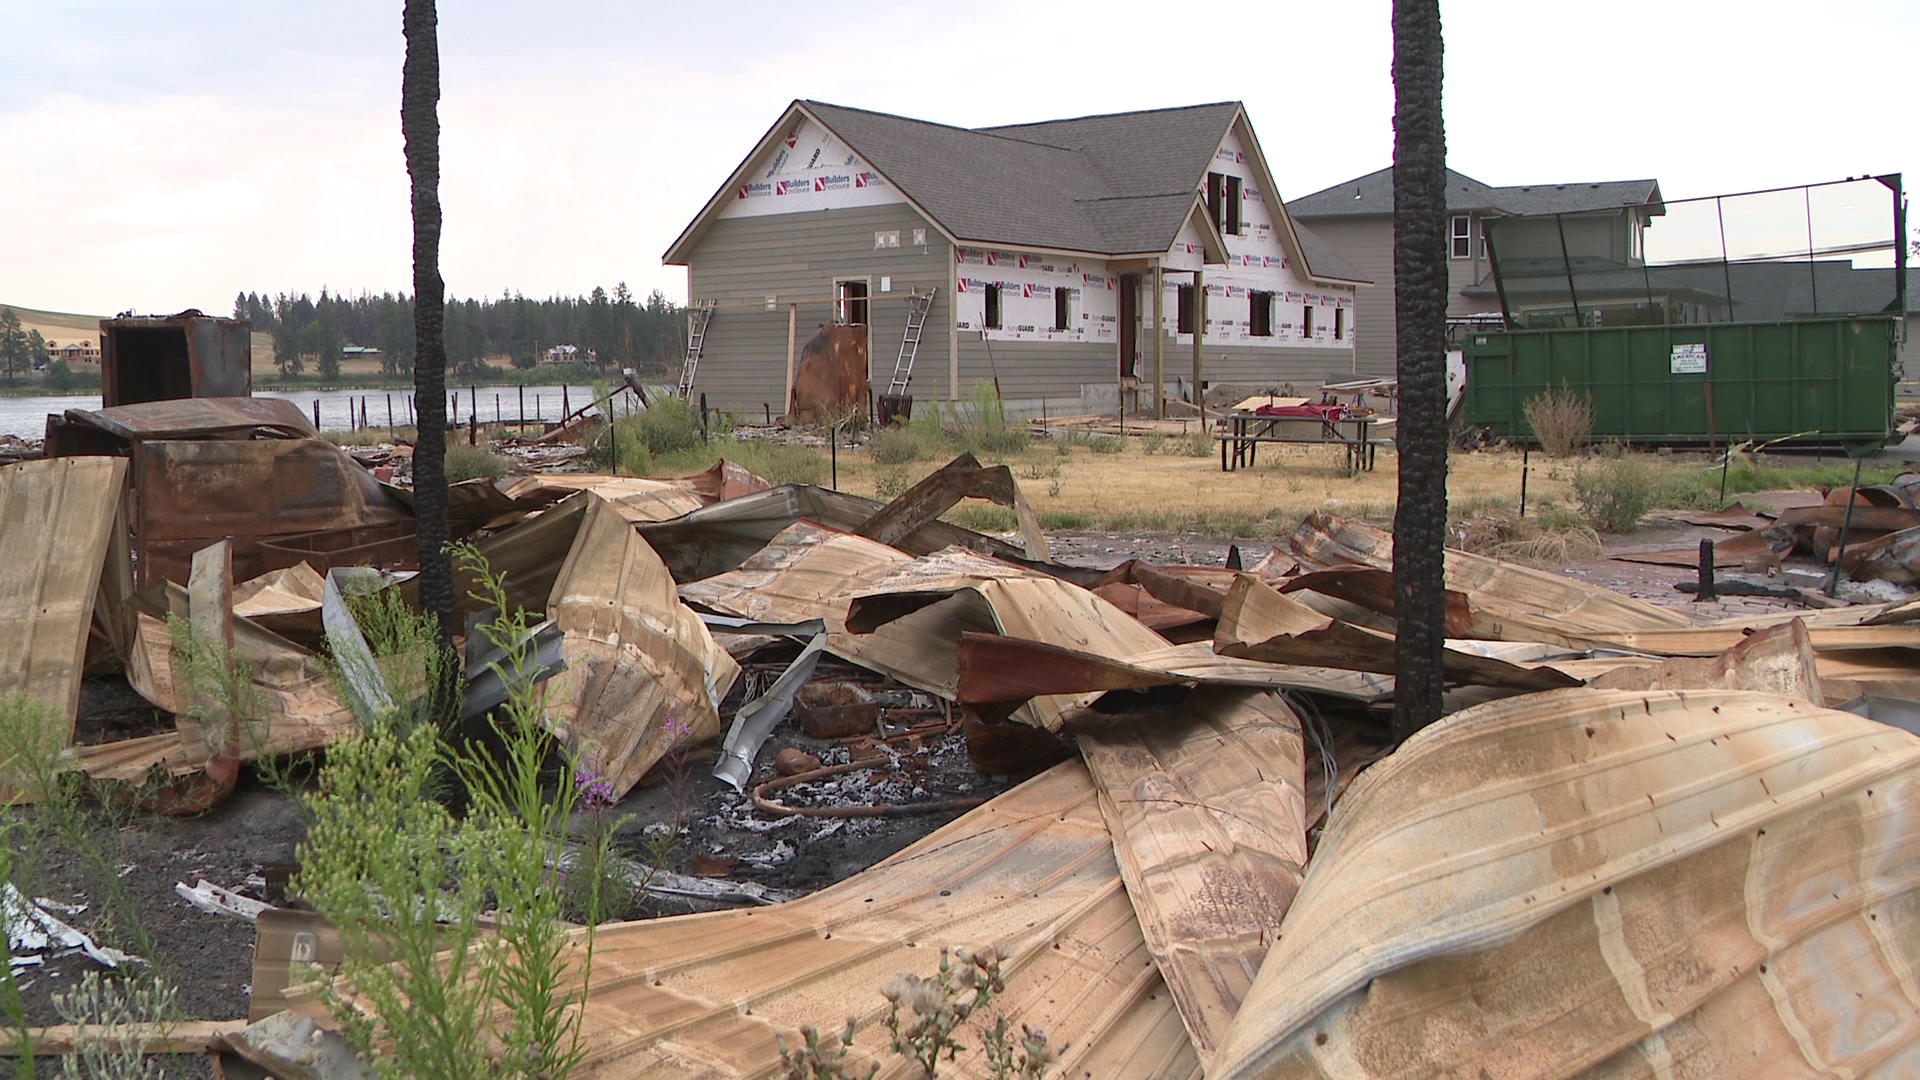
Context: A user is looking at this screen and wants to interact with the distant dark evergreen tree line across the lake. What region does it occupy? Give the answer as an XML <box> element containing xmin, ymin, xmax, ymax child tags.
<box><xmin>234</xmin><ymin>281</ymin><xmax>685</xmax><ymax>379</ymax></box>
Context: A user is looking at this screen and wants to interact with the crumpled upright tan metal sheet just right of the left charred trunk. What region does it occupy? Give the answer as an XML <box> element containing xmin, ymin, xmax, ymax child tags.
<box><xmin>543</xmin><ymin>492</ymin><xmax>739</xmax><ymax>796</ymax></box>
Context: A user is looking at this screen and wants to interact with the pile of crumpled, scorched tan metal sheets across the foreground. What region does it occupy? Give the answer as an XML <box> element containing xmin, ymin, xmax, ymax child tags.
<box><xmin>0</xmin><ymin>418</ymin><xmax>1920</xmax><ymax>1080</ymax></box>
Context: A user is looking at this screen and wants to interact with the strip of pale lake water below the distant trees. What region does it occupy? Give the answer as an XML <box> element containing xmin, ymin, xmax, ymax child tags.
<box><xmin>0</xmin><ymin>386</ymin><xmax>593</xmax><ymax>438</ymax></box>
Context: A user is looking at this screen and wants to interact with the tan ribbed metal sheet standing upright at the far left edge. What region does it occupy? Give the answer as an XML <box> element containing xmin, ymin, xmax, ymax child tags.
<box><xmin>0</xmin><ymin>457</ymin><xmax>127</xmax><ymax>730</ymax></box>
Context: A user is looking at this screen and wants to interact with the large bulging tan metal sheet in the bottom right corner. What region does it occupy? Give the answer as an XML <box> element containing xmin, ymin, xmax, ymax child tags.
<box><xmin>1210</xmin><ymin>690</ymin><xmax>1920</xmax><ymax>1080</ymax></box>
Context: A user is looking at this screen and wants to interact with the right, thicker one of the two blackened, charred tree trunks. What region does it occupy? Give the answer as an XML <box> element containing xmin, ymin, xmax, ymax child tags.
<box><xmin>1394</xmin><ymin>0</ymin><xmax>1446</xmax><ymax>738</ymax></box>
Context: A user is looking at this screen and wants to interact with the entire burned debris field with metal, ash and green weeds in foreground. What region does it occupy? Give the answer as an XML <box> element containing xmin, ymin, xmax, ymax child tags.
<box><xmin>11</xmin><ymin>388</ymin><xmax>1920</xmax><ymax>1080</ymax></box>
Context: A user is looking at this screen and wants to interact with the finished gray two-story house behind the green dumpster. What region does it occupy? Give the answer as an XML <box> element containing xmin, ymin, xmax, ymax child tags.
<box><xmin>1286</xmin><ymin>167</ymin><xmax>1658</xmax><ymax>375</ymax></box>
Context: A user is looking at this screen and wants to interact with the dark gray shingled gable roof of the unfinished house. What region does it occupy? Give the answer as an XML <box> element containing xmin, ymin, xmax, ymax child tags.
<box><xmin>664</xmin><ymin>100</ymin><xmax>1361</xmax><ymax>281</ymax></box>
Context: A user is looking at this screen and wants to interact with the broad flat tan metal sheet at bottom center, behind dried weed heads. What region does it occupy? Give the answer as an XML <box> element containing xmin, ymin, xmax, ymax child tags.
<box><xmin>255</xmin><ymin>761</ymin><xmax>1200</xmax><ymax>1080</ymax></box>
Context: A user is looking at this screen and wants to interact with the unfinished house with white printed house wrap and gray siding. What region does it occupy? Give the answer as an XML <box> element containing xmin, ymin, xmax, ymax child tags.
<box><xmin>664</xmin><ymin>102</ymin><xmax>1365</xmax><ymax>413</ymax></box>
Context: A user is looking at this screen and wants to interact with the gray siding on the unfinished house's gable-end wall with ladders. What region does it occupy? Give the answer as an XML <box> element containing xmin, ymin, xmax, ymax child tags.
<box><xmin>687</xmin><ymin>206</ymin><xmax>954</xmax><ymax>419</ymax></box>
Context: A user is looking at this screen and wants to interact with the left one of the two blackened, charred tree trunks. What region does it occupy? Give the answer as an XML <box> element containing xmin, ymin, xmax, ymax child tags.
<box><xmin>399</xmin><ymin>0</ymin><xmax>453</xmax><ymax>650</ymax></box>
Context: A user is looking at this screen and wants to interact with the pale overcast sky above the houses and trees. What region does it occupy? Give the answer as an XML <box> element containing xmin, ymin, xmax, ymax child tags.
<box><xmin>0</xmin><ymin>0</ymin><xmax>1920</xmax><ymax>313</ymax></box>
